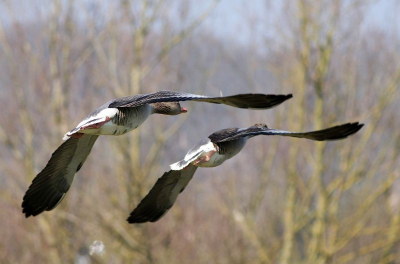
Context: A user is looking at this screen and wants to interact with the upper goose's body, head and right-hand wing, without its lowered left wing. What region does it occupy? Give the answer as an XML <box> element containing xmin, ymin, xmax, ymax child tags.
<box><xmin>63</xmin><ymin>91</ymin><xmax>292</xmax><ymax>140</ymax></box>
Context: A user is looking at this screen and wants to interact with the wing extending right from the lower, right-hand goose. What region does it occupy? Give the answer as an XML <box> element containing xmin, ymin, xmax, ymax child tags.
<box><xmin>210</xmin><ymin>122</ymin><xmax>364</xmax><ymax>143</ymax></box>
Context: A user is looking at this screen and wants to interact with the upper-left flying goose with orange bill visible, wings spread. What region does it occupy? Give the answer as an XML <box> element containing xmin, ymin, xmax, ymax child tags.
<box><xmin>22</xmin><ymin>91</ymin><xmax>292</xmax><ymax>217</ymax></box>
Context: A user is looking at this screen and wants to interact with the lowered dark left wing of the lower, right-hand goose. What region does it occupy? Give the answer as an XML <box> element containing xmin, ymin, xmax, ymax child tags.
<box><xmin>127</xmin><ymin>165</ymin><xmax>197</xmax><ymax>224</ymax></box>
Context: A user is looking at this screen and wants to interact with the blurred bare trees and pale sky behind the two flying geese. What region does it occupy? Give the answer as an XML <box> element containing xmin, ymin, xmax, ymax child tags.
<box><xmin>0</xmin><ymin>0</ymin><xmax>400</xmax><ymax>264</ymax></box>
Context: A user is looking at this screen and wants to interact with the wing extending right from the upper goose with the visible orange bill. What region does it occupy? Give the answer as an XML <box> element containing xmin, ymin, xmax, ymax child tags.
<box><xmin>108</xmin><ymin>91</ymin><xmax>292</xmax><ymax>109</ymax></box>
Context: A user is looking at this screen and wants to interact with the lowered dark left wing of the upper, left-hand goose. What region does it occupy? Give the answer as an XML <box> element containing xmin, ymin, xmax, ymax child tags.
<box><xmin>22</xmin><ymin>135</ymin><xmax>99</xmax><ymax>217</ymax></box>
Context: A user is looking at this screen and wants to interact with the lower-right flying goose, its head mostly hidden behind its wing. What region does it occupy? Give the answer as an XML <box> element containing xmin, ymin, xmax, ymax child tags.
<box><xmin>127</xmin><ymin>122</ymin><xmax>363</xmax><ymax>223</ymax></box>
